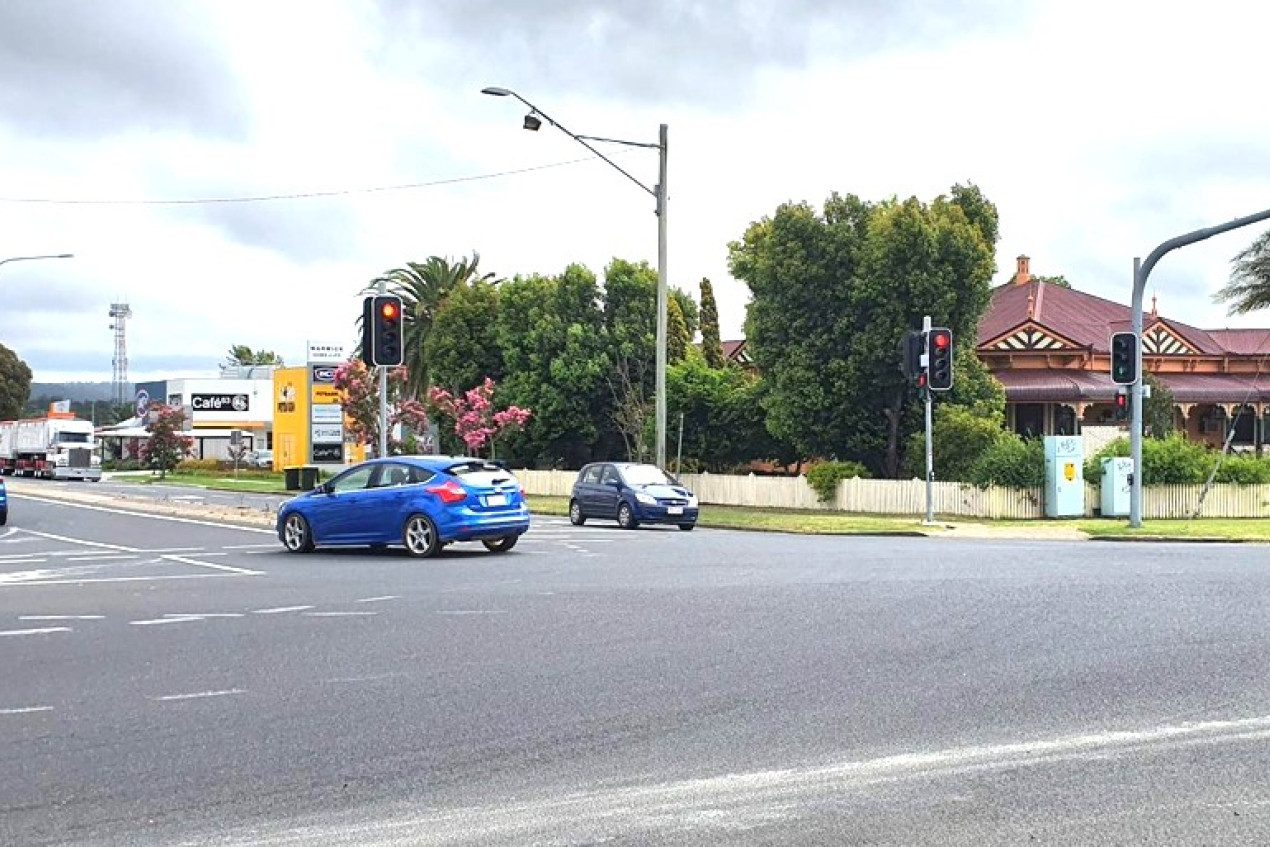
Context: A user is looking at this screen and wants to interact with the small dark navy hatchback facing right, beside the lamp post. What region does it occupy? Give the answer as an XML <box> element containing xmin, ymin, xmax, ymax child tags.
<box><xmin>569</xmin><ymin>462</ymin><xmax>699</xmax><ymax>530</ymax></box>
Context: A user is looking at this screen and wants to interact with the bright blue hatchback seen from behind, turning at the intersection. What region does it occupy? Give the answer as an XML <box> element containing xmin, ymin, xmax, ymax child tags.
<box><xmin>277</xmin><ymin>456</ymin><xmax>530</xmax><ymax>557</ymax></box>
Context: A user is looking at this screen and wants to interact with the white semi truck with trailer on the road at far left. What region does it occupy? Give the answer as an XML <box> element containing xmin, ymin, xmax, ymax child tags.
<box><xmin>0</xmin><ymin>411</ymin><xmax>102</xmax><ymax>483</ymax></box>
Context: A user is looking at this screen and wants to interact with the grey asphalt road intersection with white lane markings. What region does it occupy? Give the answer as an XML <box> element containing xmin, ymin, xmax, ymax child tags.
<box><xmin>0</xmin><ymin>486</ymin><xmax>1270</xmax><ymax>847</ymax></box>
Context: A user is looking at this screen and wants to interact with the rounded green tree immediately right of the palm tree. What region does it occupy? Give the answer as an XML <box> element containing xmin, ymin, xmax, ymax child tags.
<box><xmin>423</xmin><ymin>279</ymin><xmax>504</xmax><ymax>394</ymax></box>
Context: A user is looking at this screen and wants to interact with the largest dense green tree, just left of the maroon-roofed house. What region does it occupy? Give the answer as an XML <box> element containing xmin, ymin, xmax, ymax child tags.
<box><xmin>729</xmin><ymin>185</ymin><xmax>998</xmax><ymax>476</ymax></box>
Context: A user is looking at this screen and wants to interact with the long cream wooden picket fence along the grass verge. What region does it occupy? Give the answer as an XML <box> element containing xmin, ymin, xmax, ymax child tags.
<box><xmin>516</xmin><ymin>470</ymin><xmax>1270</xmax><ymax>521</ymax></box>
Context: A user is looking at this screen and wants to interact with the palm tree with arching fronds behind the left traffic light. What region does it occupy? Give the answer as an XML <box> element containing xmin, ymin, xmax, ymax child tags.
<box><xmin>363</xmin><ymin>250</ymin><xmax>494</xmax><ymax>399</ymax></box>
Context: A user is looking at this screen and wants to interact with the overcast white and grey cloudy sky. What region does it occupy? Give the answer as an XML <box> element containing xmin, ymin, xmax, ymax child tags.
<box><xmin>0</xmin><ymin>0</ymin><xmax>1270</xmax><ymax>381</ymax></box>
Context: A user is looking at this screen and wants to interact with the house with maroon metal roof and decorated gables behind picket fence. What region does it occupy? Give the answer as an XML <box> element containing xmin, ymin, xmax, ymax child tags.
<box><xmin>977</xmin><ymin>257</ymin><xmax>1270</xmax><ymax>447</ymax></box>
